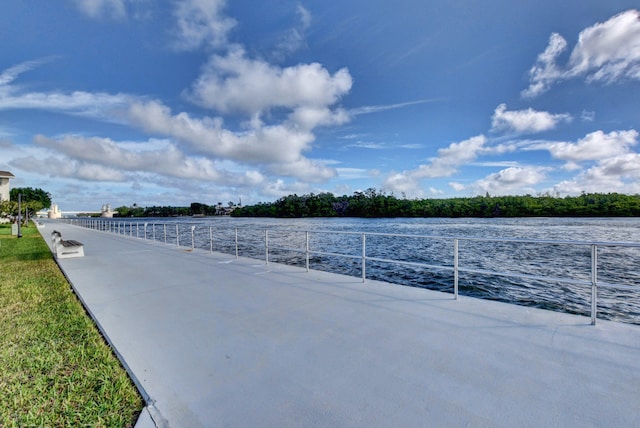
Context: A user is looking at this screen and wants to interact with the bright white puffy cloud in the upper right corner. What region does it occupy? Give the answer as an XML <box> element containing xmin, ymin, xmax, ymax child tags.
<box><xmin>522</xmin><ymin>10</ymin><xmax>640</xmax><ymax>98</ymax></box>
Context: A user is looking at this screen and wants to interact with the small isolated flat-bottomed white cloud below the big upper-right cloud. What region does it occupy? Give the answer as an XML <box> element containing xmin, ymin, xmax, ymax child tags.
<box><xmin>491</xmin><ymin>104</ymin><xmax>572</xmax><ymax>134</ymax></box>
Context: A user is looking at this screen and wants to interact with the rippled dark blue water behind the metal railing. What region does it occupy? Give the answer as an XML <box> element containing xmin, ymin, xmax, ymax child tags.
<box><xmin>100</xmin><ymin>217</ymin><xmax>640</xmax><ymax>324</ymax></box>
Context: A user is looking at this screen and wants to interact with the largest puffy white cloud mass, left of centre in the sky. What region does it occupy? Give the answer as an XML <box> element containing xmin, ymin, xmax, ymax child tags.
<box><xmin>129</xmin><ymin>48</ymin><xmax>352</xmax><ymax>181</ymax></box>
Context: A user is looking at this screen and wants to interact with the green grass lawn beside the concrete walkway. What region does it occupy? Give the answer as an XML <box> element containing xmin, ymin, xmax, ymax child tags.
<box><xmin>0</xmin><ymin>225</ymin><xmax>144</xmax><ymax>427</ymax></box>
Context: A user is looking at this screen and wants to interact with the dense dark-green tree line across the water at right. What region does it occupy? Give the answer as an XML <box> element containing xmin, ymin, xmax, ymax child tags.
<box><xmin>231</xmin><ymin>188</ymin><xmax>640</xmax><ymax>218</ymax></box>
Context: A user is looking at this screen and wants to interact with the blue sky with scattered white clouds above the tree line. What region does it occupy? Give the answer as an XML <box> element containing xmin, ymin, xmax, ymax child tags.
<box><xmin>0</xmin><ymin>0</ymin><xmax>640</xmax><ymax>210</ymax></box>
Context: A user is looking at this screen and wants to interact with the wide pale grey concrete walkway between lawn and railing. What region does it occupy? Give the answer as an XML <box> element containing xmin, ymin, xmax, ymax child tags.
<box><xmin>41</xmin><ymin>221</ymin><xmax>640</xmax><ymax>427</ymax></box>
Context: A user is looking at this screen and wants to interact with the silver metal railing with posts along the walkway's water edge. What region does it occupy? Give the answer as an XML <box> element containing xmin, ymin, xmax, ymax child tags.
<box><xmin>63</xmin><ymin>219</ymin><xmax>640</xmax><ymax>324</ymax></box>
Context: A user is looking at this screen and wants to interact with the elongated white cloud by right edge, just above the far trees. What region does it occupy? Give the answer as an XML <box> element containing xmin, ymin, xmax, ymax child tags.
<box><xmin>528</xmin><ymin>129</ymin><xmax>638</xmax><ymax>162</ymax></box>
